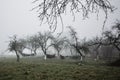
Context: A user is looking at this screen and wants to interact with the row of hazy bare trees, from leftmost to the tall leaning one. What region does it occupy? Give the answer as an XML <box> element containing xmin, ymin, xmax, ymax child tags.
<box><xmin>8</xmin><ymin>26</ymin><xmax>88</xmax><ymax>62</ymax></box>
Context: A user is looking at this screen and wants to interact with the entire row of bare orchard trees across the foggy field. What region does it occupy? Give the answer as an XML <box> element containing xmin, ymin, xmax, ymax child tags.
<box><xmin>9</xmin><ymin>22</ymin><xmax>120</xmax><ymax>61</ymax></box>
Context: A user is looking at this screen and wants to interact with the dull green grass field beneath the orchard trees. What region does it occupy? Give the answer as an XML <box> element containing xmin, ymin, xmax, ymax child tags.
<box><xmin>0</xmin><ymin>58</ymin><xmax>120</xmax><ymax>80</ymax></box>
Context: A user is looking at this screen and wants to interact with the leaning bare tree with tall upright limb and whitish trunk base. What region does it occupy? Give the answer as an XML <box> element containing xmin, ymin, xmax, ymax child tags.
<box><xmin>68</xmin><ymin>26</ymin><xmax>89</xmax><ymax>61</ymax></box>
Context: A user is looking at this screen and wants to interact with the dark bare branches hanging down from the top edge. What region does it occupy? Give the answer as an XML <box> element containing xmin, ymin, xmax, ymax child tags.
<box><xmin>33</xmin><ymin>0</ymin><xmax>114</xmax><ymax>30</ymax></box>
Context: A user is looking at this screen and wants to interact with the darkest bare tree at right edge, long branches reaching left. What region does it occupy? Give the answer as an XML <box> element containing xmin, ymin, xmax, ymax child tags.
<box><xmin>89</xmin><ymin>21</ymin><xmax>120</xmax><ymax>59</ymax></box>
